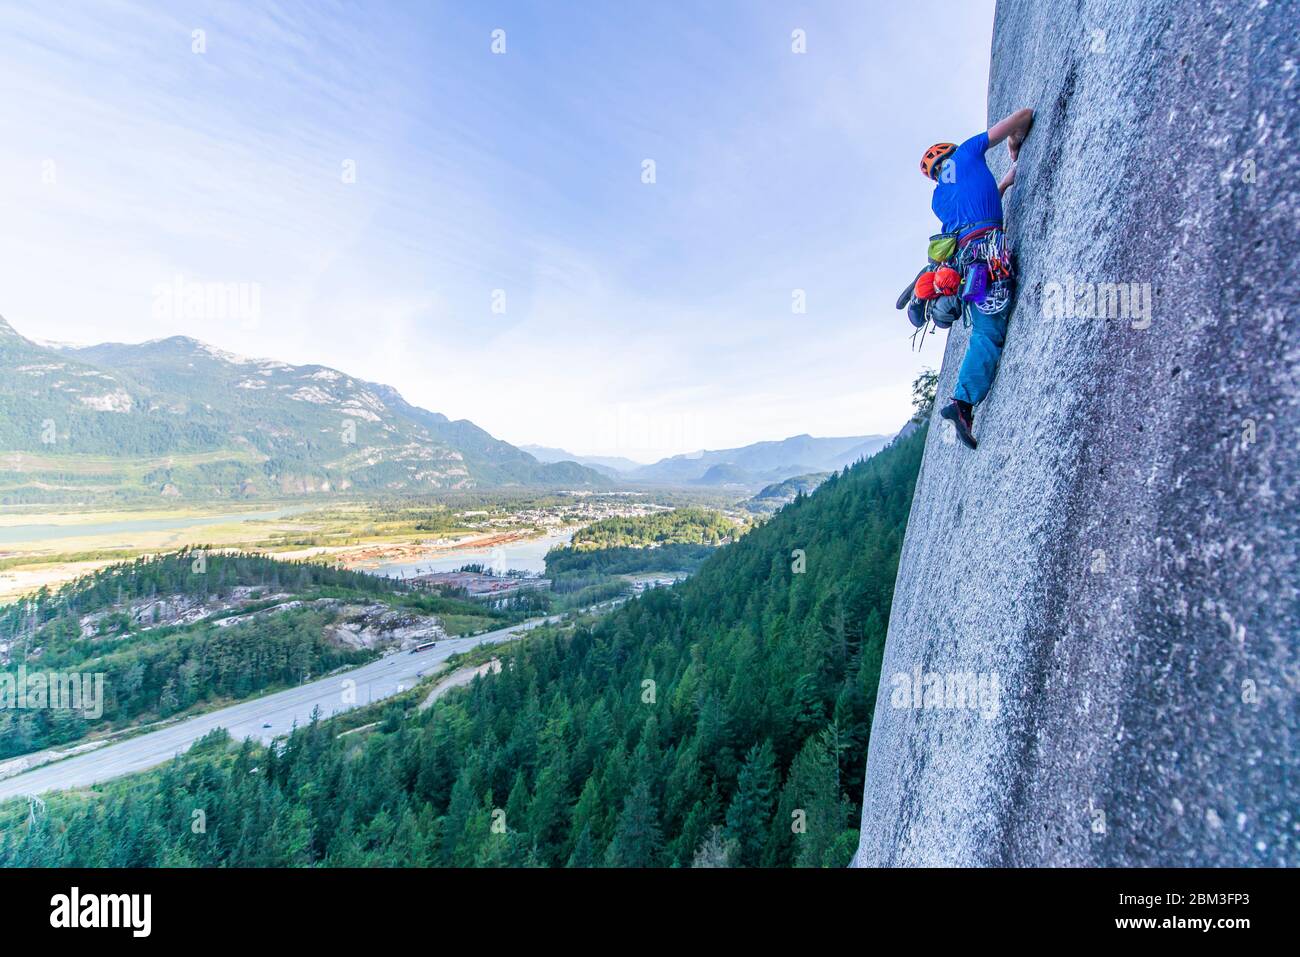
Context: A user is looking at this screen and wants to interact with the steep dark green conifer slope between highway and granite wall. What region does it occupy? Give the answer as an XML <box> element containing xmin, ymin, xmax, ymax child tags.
<box><xmin>0</xmin><ymin>430</ymin><xmax>924</xmax><ymax>866</ymax></box>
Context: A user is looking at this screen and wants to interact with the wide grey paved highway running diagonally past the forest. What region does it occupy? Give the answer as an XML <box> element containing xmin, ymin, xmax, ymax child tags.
<box><xmin>0</xmin><ymin>616</ymin><xmax>559</xmax><ymax>801</ymax></box>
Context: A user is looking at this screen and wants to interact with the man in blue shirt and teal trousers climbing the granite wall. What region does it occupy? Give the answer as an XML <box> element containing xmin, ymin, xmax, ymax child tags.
<box><xmin>920</xmin><ymin>109</ymin><xmax>1034</xmax><ymax>449</ymax></box>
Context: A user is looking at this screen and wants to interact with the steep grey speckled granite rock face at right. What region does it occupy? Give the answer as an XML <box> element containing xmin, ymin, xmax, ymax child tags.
<box><xmin>854</xmin><ymin>0</ymin><xmax>1300</xmax><ymax>866</ymax></box>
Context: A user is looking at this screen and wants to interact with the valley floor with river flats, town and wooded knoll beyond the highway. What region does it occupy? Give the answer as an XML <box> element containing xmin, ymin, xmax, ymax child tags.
<box><xmin>0</xmin><ymin>495</ymin><xmax>759</xmax><ymax>778</ymax></box>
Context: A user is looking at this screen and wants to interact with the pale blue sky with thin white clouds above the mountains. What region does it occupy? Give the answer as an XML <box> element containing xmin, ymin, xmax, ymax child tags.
<box><xmin>0</xmin><ymin>0</ymin><xmax>993</xmax><ymax>460</ymax></box>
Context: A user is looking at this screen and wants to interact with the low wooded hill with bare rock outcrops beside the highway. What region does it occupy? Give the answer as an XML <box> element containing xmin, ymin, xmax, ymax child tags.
<box><xmin>0</xmin><ymin>551</ymin><xmax>517</xmax><ymax>758</ymax></box>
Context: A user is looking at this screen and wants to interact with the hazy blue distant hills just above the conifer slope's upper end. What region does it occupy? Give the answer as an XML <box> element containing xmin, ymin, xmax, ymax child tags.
<box><xmin>625</xmin><ymin>436</ymin><xmax>892</xmax><ymax>485</ymax></box>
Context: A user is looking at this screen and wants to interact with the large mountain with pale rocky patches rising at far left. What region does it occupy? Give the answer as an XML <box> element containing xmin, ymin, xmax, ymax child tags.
<box><xmin>0</xmin><ymin>319</ymin><xmax>610</xmax><ymax>503</ymax></box>
